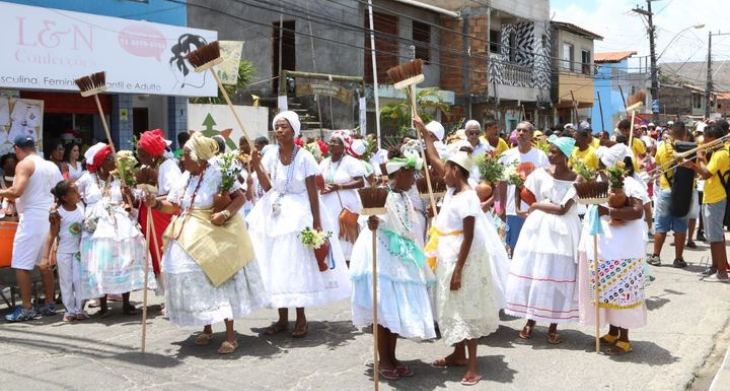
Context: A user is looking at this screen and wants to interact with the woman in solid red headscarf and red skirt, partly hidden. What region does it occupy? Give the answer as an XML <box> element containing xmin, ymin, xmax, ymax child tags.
<box><xmin>137</xmin><ymin>129</ymin><xmax>182</xmax><ymax>282</ymax></box>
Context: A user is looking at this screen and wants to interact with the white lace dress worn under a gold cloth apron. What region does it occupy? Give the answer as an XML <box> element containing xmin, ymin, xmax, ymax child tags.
<box><xmin>162</xmin><ymin>166</ymin><xmax>268</xmax><ymax>327</ymax></box>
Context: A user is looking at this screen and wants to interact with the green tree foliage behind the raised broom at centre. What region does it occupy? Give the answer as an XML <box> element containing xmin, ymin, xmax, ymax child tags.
<box><xmin>380</xmin><ymin>87</ymin><xmax>449</xmax><ymax>137</ymax></box>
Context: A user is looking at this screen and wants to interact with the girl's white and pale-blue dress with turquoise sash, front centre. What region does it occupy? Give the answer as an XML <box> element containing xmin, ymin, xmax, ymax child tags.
<box><xmin>350</xmin><ymin>192</ymin><xmax>436</xmax><ymax>339</ymax></box>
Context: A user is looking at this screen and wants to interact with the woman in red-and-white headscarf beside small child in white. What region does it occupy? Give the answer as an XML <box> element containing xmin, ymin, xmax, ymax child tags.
<box><xmin>76</xmin><ymin>143</ymin><xmax>157</xmax><ymax>315</ymax></box>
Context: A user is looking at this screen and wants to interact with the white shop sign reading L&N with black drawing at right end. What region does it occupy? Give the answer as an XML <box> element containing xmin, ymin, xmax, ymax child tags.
<box><xmin>0</xmin><ymin>2</ymin><xmax>218</xmax><ymax>96</ymax></box>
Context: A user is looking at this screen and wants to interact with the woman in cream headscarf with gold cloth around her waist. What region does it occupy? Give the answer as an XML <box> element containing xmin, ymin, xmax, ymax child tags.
<box><xmin>145</xmin><ymin>133</ymin><xmax>268</xmax><ymax>354</ymax></box>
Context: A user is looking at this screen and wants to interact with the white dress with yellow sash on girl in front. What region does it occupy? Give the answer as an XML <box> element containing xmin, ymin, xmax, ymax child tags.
<box><xmin>434</xmin><ymin>189</ymin><xmax>500</xmax><ymax>345</ymax></box>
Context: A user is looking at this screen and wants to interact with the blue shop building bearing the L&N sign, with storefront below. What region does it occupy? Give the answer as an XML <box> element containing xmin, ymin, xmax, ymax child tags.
<box><xmin>0</xmin><ymin>0</ymin><xmax>209</xmax><ymax>154</ymax></box>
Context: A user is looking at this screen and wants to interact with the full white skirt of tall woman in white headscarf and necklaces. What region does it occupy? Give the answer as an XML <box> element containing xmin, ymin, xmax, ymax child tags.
<box><xmin>247</xmin><ymin>191</ymin><xmax>352</xmax><ymax>308</ymax></box>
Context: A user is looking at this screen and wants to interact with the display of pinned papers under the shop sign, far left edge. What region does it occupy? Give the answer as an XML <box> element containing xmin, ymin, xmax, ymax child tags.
<box><xmin>0</xmin><ymin>96</ymin><xmax>43</xmax><ymax>156</ymax></box>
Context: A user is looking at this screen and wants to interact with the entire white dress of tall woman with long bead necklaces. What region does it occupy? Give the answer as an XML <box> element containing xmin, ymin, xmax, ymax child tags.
<box><xmin>246</xmin><ymin>147</ymin><xmax>352</xmax><ymax>308</ymax></box>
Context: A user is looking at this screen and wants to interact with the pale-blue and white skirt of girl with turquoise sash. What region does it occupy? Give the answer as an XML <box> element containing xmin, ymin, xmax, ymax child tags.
<box><xmin>350</xmin><ymin>230</ymin><xmax>436</xmax><ymax>339</ymax></box>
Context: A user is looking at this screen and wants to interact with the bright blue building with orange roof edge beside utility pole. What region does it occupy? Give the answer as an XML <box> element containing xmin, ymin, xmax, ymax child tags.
<box><xmin>591</xmin><ymin>51</ymin><xmax>650</xmax><ymax>133</ymax></box>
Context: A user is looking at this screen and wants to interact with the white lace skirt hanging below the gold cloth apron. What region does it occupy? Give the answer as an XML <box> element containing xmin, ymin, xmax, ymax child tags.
<box><xmin>163</xmin><ymin>241</ymin><xmax>268</xmax><ymax>327</ymax></box>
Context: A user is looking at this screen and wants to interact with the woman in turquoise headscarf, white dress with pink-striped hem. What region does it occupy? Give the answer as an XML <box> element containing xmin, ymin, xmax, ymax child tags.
<box><xmin>505</xmin><ymin>135</ymin><xmax>581</xmax><ymax>344</ymax></box>
